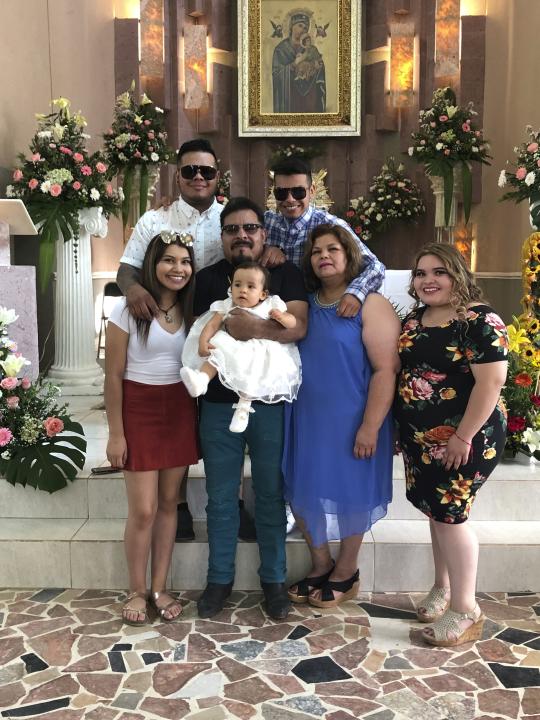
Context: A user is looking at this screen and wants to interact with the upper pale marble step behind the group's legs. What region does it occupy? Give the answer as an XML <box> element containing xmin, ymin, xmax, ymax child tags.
<box><xmin>0</xmin><ymin>456</ymin><xmax>540</xmax><ymax>521</ymax></box>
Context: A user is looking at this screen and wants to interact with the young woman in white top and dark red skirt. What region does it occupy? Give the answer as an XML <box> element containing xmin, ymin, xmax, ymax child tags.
<box><xmin>105</xmin><ymin>231</ymin><xmax>199</xmax><ymax>625</ymax></box>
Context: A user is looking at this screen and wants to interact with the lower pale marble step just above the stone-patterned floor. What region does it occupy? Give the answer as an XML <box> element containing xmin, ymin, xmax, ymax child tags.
<box><xmin>0</xmin><ymin>518</ymin><xmax>540</xmax><ymax>592</ymax></box>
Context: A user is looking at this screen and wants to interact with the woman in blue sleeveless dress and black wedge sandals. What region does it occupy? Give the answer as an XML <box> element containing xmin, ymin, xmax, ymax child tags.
<box><xmin>283</xmin><ymin>225</ymin><xmax>400</xmax><ymax>607</ymax></box>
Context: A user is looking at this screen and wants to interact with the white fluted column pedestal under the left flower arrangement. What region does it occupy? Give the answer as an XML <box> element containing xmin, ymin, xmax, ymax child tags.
<box><xmin>48</xmin><ymin>208</ymin><xmax>107</xmax><ymax>395</ymax></box>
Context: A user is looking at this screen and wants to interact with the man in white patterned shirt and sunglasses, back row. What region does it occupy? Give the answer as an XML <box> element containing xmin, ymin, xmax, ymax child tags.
<box><xmin>116</xmin><ymin>138</ymin><xmax>223</xmax><ymax>320</ymax></box>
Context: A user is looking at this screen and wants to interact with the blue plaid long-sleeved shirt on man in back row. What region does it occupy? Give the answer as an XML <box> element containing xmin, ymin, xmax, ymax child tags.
<box><xmin>264</xmin><ymin>205</ymin><xmax>385</xmax><ymax>302</ymax></box>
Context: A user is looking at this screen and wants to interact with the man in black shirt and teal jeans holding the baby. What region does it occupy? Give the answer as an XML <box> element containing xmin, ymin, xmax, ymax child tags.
<box><xmin>193</xmin><ymin>198</ymin><xmax>308</xmax><ymax>619</ymax></box>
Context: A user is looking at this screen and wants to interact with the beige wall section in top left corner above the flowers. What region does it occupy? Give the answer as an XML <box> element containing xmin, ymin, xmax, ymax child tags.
<box><xmin>0</xmin><ymin>0</ymin><xmax>51</xmax><ymax>168</ymax></box>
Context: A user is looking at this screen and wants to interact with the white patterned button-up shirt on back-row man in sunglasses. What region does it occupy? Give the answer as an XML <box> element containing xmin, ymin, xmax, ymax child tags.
<box><xmin>120</xmin><ymin>198</ymin><xmax>223</xmax><ymax>270</ymax></box>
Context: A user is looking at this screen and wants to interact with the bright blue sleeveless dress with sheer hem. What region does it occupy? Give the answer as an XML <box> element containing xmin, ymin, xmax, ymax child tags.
<box><xmin>282</xmin><ymin>296</ymin><xmax>393</xmax><ymax>547</ymax></box>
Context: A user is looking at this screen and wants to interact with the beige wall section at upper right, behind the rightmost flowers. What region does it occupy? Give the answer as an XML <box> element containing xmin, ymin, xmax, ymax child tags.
<box><xmin>473</xmin><ymin>0</ymin><xmax>540</xmax><ymax>272</ymax></box>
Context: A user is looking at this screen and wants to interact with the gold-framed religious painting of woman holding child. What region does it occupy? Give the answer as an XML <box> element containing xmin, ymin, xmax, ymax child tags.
<box><xmin>238</xmin><ymin>0</ymin><xmax>361</xmax><ymax>137</ymax></box>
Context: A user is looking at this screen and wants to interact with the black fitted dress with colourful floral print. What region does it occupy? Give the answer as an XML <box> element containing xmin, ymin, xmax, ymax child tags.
<box><xmin>395</xmin><ymin>305</ymin><xmax>508</xmax><ymax>523</ymax></box>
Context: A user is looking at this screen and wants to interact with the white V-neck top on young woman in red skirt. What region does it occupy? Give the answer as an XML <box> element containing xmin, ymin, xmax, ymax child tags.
<box><xmin>109</xmin><ymin>298</ymin><xmax>186</xmax><ymax>385</ymax></box>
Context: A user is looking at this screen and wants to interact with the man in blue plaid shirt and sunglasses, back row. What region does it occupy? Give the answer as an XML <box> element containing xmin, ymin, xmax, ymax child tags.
<box><xmin>263</xmin><ymin>158</ymin><xmax>385</xmax><ymax>317</ymax></box>
